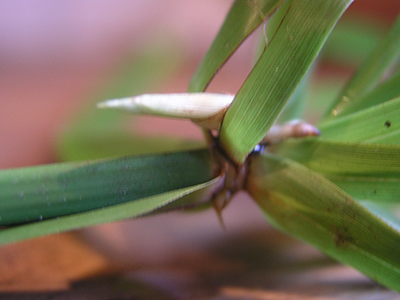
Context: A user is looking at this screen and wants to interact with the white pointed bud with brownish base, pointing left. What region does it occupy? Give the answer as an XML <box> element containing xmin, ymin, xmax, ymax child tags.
<box><xmin>97</xmin><ymin>93</ymin><xmax>234</xmax><ymax>130</ymax></box>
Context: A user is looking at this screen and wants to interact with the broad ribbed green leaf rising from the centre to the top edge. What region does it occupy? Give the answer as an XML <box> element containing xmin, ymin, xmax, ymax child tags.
<box><xmin>220</xmin><ymin>0</ymin><xmax>352</xmax><ymax>163</ymax></box>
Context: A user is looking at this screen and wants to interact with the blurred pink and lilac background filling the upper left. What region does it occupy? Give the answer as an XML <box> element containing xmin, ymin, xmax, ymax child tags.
<box><xmin>0</xmin><ymin>0</ymin><xmax>241</xmax><ymax>168</ymax></box>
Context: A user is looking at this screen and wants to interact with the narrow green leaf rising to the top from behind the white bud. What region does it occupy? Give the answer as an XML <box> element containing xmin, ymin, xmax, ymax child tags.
<box><xmin>189</xmin><ymin>0</ymin><xmax>284</xmax><ymax>92</ymax></box>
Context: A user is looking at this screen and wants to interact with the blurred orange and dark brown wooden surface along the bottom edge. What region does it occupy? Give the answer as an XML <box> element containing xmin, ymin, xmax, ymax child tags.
<box><xmin>0</xmin><ymin>226</ymin><xmax>400</xmax><ymax>300</ymax></box>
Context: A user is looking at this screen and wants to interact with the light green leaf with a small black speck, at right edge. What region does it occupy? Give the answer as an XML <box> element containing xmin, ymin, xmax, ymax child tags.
<box><xmin>318</xmin><ymin>98</ymin><xmax>400</xmax><ymax>144</ymax></box>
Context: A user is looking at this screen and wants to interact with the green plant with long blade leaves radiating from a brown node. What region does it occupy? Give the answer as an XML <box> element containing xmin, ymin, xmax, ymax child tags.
<box><xmin>0</xmin><ymin>0</ymin><xmax>400</xmax><ymax>291</ymax></box>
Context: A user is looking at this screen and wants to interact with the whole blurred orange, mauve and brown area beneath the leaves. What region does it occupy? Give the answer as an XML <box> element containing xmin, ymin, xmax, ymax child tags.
<box><xmin>0</xmin><ymin>193</ymin><xmax>400</xmax><ymax>300</ymax></box>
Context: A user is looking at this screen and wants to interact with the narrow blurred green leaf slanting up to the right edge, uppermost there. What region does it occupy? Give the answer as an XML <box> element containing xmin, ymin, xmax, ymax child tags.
<box><xmin>325</xmin><ymin>16</ymin><xmax>400</xmax><ymax>118</ymax></box>
